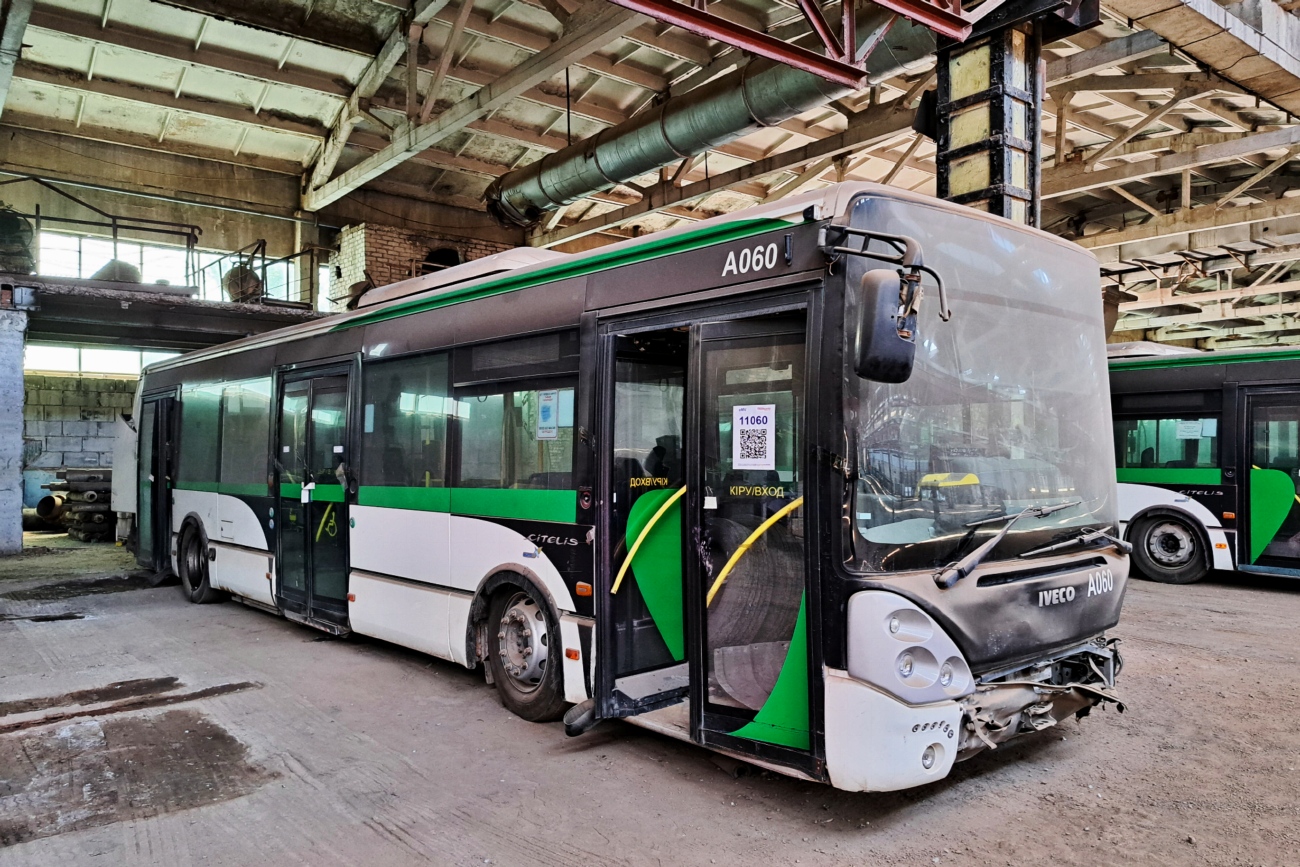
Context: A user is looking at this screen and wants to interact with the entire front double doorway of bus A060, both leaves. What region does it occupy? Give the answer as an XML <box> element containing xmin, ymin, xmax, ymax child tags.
<box><xmin>595</xmin><ymin>311</ymin><xmax>810</xmax><ymax>766</ymax></box>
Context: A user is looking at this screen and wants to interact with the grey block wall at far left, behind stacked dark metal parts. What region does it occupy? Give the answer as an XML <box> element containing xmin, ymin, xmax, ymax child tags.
<box><xmin>22</xmin><ymin>373</ymin><xmax>138</xmax><ymax>506</ymax></box>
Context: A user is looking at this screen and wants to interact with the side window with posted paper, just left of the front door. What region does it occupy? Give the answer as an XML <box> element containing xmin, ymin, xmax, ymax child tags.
<box><xmin>456</xmin><ymin>383</ymin><xmax>573</xmax><ymax>490</ymax></box>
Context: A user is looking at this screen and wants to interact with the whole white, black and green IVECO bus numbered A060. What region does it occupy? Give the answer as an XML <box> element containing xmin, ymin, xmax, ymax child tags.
<box><xmin>126</xmin><ymin>185</ymin><xmax>1127</xmax><ymax>790</ymax></box>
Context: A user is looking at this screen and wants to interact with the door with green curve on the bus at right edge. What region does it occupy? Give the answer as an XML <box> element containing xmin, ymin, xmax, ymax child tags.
<box><xmin>1239</xmin><ymin>391</ymin><xmax>1300</xmax><ymax>569</ymax></box>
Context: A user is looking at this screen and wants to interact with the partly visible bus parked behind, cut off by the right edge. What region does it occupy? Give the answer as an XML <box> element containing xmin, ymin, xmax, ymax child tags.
<box><xmin>1110</xmin><ymin>344</ymin><xmax>1300</xmax><ymax>584</ymax></box>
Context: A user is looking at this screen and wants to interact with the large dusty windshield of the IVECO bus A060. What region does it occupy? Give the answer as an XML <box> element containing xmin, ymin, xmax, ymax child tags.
<box><xmin>846</xmin><ymin>201</ymin><xmax>1115</xmax><ymax>571</ymax></box>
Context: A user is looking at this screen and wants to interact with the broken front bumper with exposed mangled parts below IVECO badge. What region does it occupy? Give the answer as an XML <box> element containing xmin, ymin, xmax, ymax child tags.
<box><xmin>957</xmin><ymin>638</ymin><xmax>1125</xmax><ymax>762</ymax></box>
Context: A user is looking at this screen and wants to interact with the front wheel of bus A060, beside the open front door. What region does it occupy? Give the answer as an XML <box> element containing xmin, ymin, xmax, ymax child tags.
<box><xmin>486</xmin><ymin>581</ymin><xmax>566</xmax><ymax>723</ymax></box>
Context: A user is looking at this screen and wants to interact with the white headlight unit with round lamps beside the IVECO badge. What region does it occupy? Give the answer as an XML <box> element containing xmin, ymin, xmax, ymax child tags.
<box><xmin>848</xmin><ymin>590</ymin><xmax>975</xmax><ymax>705</ymax></box>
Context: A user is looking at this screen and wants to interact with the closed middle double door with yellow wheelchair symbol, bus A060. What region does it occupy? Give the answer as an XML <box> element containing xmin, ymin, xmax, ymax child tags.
<box><xmin>276</xmin><ymin>370</ymin><xmax>352</xmax><ymax>632</ymax></box>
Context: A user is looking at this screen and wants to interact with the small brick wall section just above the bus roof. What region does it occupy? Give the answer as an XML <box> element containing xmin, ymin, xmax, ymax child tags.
<box><xmin>329</xmin><ymin>222</ymin><xmax>511</xmax><ymax>310</ymax></box>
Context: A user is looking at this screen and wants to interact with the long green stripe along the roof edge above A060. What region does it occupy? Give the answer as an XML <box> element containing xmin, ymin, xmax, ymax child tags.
<box><xmin>330</xmin><ymin>217</ymin><xmax>792</xmax><ymax>331</ymax></box>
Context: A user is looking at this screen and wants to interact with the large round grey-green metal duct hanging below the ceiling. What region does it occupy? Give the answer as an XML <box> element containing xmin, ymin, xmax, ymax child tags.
<box><xmin>484</xmin><ymin>11</ymin><xmax>935</xmax><ymax>226</ymax></box>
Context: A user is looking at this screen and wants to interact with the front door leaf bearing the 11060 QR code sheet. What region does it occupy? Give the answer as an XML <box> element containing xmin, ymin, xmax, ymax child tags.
<box><xmin>688</xmin><ymin>312</ymin><xmax>810</xmax><ymax>751</ymax></box>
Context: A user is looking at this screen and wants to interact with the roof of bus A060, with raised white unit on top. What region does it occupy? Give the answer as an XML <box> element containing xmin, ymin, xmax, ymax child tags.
<box><xmin>147</xmin><ymin>182</ymin><xmax>1084</xmax><ymax>370</ymax></box>
